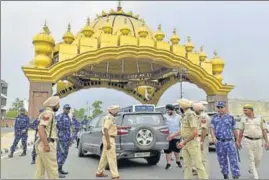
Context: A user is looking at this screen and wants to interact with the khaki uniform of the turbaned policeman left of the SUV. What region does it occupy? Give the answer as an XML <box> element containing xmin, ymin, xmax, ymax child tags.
<box><xmin>36</xmin><ymin>107</ymin><xmax>59</xmax><ymax>179</ymax></box>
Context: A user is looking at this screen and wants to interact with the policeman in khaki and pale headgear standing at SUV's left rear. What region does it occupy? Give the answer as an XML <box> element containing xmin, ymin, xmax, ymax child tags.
<box><xmin>96</xmin><ymin>105</ymin><xmax>130</xmax><ymax>179</ymax></box>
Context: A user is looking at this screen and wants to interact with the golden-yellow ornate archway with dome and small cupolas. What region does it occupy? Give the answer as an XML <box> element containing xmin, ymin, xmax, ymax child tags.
<box><xmin>22</xmin><ymin>2</ymin><xmax>233</xmax><ymax>118</ymax></box>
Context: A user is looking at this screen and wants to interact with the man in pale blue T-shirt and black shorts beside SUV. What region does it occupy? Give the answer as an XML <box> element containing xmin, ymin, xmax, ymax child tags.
<box><xmin>164</xmin><ymin>104</ymin><xmax>182</xmax><ymax>170</ymax></box>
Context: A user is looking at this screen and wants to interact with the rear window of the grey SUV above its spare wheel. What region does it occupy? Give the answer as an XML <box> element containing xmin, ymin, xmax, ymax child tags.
<box><xmin>123</xmin><ymin>114</ymin><xmax>163</xmax><ymax>126</ymax></box>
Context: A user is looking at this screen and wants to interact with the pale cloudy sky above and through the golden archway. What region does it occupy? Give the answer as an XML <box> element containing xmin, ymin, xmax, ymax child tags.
<box><xmin>1</xmin><ymin>1</ymin><xmax>269</xmax><ymax>111</ymax></box>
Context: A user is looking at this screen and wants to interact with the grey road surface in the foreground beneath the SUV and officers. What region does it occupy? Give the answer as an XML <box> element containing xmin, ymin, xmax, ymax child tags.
<box><xmin>1</xmin><ymin>144</ymin><xmax>269</xmax><ymax>179</ymax></box>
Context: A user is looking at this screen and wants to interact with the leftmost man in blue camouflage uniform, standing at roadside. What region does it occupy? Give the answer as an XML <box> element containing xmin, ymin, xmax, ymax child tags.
<box><xmin>8</xmin><ymin>107</ymin><xmax>30</xmax><ymax>158</ymax></box>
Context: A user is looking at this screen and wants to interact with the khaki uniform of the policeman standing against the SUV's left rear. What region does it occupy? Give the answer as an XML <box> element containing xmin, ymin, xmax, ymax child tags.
<box><xmin>97</xmin><ymin>114</ymin><xmax>119</xmax><ymax>178</ymax></box>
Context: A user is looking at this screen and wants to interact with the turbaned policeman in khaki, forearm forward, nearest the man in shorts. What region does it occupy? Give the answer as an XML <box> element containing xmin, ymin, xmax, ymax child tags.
<box><xmin>168</xmin><ymin>99</ymin><xmax>208</xmax><ymax>179</ymax></box>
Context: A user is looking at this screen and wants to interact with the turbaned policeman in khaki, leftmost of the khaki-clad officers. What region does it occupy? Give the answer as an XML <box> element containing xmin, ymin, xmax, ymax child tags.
<box><xmin>36</xmin><ymin>96</ymin><xmax>60</xmax><ymax>179</ymax></box>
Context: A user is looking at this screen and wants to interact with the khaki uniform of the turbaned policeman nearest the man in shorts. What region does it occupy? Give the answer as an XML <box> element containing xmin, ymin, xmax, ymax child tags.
<box><xmin>181</xmin><ymin>109</ymin><xmax>208</xmax><ymax>179</ymax></box>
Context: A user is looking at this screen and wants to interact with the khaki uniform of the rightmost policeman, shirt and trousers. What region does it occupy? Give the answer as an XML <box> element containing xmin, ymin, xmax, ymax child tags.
<box><xmin>239</xmin><ymin>117</ymin><xmax>267</xmax><ymax>179</ymax></box>
